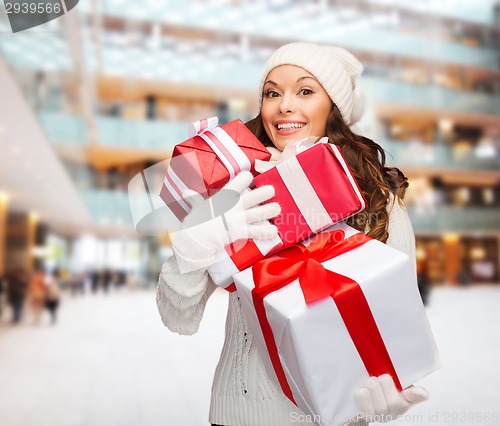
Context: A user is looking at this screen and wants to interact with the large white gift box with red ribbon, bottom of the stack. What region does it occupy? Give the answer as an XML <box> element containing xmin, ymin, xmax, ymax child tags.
<box><xmin>234</xmin><ymin>223</ymin><xmax>440</xmax><ymax>426</ymax></box>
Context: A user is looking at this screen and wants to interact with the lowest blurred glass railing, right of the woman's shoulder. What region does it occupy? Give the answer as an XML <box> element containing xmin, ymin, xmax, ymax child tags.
<box><xmin>407</xmin><ymin>206</ymin><xmax>500</xmax><ymax>232</ymax></box>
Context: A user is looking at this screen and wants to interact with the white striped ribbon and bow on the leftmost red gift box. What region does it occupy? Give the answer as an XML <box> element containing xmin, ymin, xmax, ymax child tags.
<box><xmin>164</xmin><ymin>117</ymin><xmax>252</xmax><ymax>213</ymax></box>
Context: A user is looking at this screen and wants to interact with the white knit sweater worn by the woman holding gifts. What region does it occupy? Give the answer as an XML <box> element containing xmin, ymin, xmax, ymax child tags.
<box><xmin>156</xmin><ymin>195</ymin><xmax>415</xmax><ymax>426</ymax></box>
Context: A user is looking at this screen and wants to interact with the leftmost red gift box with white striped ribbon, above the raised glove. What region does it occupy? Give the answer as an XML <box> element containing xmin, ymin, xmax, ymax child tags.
<box><xmin>160</xmin><ymin>117</ymin><xmax>271</xmax><ymax>220</ymax></box>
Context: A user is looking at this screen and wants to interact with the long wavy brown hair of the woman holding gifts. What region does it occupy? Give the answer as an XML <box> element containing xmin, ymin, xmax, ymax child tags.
<box><xmin>246</xmin><ymin>104</ymin><xmax>408</xmax><ymax>242</ymax></box>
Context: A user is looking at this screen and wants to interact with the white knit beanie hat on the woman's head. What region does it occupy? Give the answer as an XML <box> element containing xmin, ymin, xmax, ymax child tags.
<box><xmin>259</xmin><ymin>42</ymin><xmax>365</xmax><ymax>126</ymax></box>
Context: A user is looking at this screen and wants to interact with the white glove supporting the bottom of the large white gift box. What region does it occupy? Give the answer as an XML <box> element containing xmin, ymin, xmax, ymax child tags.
<box><xmin>354</xmin><ymin>374</ymin><xmax>429</xmax><ymax>423</ymax></box>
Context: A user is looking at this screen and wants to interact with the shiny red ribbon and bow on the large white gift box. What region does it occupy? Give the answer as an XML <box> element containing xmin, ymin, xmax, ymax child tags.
<box><xmin>252</xmin><ymin>230</ymin><xmax>402</xmax><ymax>404</ymax></box>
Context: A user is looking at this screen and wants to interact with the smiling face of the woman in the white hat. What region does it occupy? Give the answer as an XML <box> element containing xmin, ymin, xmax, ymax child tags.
<box><xmin>261</xmin><ymin>65</ymin><xmax>332</xmax><ymax>151</ymax></box>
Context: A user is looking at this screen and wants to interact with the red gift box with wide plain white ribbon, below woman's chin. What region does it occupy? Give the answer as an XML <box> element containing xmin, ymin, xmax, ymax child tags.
<box><xmin>254</xmin><ymin>138</ymin><xmax>365</xmax><ymax>246</ymax></box>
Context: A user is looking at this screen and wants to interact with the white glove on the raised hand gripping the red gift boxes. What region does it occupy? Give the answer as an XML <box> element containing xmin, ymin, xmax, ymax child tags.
<box><xmin>172</xmin><ymin>172</ymin><xmax>281</xmax><ymax>273</ymax></box>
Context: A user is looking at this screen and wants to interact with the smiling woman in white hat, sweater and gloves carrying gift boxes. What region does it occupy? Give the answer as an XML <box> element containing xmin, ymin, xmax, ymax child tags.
<box><xmin>157</xmin><ymin>43</ymin><xmax>427</xmax><ymax>426</ymax></box>
